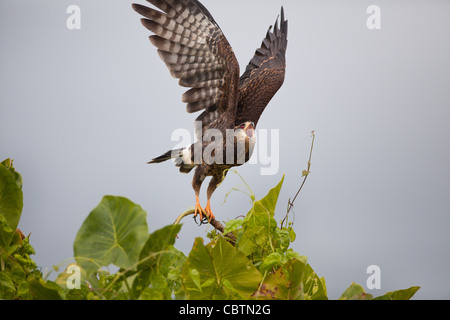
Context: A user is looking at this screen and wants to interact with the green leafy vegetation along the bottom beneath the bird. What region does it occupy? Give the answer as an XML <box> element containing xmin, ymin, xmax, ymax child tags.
<box><xmin>0</xmin><ymin>159</ymin><xmax>419</xmax><ymax>300</ymax></box>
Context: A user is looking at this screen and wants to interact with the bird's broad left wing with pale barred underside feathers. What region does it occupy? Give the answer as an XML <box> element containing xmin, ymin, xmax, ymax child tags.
<box><xmin>133</xmin><ymin>0</ymin><xmax>239</xmax><ymax>136</ymax></box>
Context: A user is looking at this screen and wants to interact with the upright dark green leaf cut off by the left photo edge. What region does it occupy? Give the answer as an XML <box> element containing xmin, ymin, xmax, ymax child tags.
<box><xmin>0</xmin><ymin>163</ymin><xmax>23</xmax><ymax>248</ymax></box>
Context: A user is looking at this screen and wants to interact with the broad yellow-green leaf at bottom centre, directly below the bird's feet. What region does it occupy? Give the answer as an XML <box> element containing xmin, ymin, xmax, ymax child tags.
<box><xmin>182</xmin><ymin>238</ymin><xmax>262</xmax><ymax>300</ymax></box>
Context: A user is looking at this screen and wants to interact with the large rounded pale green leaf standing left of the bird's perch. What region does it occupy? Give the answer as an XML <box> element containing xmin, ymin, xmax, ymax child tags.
<box><xmin>74</xmin><ymin>196</ymin><xmax>148</xmax><ymax>280</ymax></box>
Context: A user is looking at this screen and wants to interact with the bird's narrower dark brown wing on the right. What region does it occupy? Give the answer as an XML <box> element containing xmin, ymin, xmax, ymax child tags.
<box><xmin>236</xmin><ymin>8</ymin><xmax>288</xmax><ymax>125</ymax></box>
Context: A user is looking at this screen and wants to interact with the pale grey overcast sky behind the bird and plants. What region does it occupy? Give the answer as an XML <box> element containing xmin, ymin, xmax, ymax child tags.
<box><xmin>0</xmin><ymin>0</ymin><xmax>450</xmax><ymax>299</ymax></box>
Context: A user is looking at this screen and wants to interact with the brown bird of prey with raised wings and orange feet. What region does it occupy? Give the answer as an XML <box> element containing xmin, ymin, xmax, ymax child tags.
<box><xmin>133</xmin><ymin>0</ymin><xmax>288</xmax><ymax>222</ymax></box>
